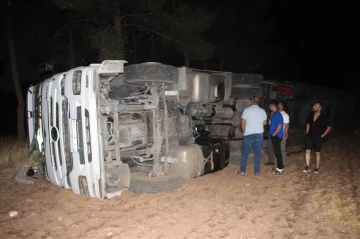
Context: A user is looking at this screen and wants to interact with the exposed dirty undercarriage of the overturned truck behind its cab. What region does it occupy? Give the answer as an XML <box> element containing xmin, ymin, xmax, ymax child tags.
<box><xmin>99</xmin><ymin>63</ymin><xmax>238</xmax><ymax>195</ymax></box>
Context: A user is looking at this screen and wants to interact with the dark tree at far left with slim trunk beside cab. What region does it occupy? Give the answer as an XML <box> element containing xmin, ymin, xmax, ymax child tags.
<box><xmin>0</xmin><ymin>0</ymin><xmax>87</xmax><ymax>139</ymax></box>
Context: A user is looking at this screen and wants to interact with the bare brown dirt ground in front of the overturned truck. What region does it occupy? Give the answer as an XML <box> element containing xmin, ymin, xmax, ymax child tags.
<box><xmin>0</xmin><ymin>136</ymin><xmax>360</xmax><ymax>239</ymax></box>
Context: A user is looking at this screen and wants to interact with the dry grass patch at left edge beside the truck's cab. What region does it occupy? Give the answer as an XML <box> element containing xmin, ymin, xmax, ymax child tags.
<box><xmin>0</xmin><ymin>137</ymin><xmax>30</xmax><ymax>169</ymax></box>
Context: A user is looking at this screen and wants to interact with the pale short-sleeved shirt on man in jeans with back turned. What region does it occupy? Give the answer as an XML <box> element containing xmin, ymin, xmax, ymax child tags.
<box><xmin>241</xmin><ymin>105</ymin><xmax>267</xmax><ymax>136</ymax></box>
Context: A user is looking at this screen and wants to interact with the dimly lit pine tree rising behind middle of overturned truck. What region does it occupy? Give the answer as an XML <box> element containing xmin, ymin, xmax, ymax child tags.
<box><xmin>53</xmin><ymin>0</ymin><xmax>214</xmax><ymax>65</ymax></box>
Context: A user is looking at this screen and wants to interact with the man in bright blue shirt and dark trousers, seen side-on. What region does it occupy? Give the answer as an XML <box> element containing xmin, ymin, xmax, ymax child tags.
<box><xmin>269</xmin><ymin>101</ymin><xmax>284</xmax><ymax>174</ymax></box>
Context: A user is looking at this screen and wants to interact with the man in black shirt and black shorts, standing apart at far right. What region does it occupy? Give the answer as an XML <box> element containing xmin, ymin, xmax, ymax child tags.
<box><xmin>303</xmin><ymin>102</ymin><xmax>331</xmax><ymax>173</ymax></box>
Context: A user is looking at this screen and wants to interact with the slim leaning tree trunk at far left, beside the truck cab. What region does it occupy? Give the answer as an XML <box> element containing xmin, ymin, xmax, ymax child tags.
<box><xmin>5</xmin><ymin>5</ymin><xmax>25</xmax><ymax>140</ymax></box>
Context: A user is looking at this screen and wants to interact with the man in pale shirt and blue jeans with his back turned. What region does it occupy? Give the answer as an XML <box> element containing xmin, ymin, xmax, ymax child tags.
<box><xmin>238</xmin><ymin>96</ymin><xmax>267</xmax><ymax>175</ymax></box>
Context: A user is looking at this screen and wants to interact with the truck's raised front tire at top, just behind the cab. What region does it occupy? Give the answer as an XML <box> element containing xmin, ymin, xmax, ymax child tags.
<box><xmin>124</xmin><ymin>62</ymin><xmax>178</xmax><ymax>85</ymax></box>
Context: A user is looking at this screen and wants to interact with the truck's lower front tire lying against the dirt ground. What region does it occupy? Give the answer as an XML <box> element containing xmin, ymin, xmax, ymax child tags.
<box><xmin>129</xmin><ymin>172</ymin><xmax>182</xmax><ymax>194</ymax></box>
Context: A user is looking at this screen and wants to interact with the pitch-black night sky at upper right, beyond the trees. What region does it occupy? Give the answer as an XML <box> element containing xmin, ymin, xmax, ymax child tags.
<box><xmin>271</xmin><ymin>1</ymin><xmax>360</xmax><ymax>88</ymax></box>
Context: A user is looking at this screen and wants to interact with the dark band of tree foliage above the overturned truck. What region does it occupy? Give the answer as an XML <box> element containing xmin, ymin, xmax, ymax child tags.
<box><xmin>0</xmin><ymin>0</ymin><xmax>286</xmax><ymax>90</ymax></box>
